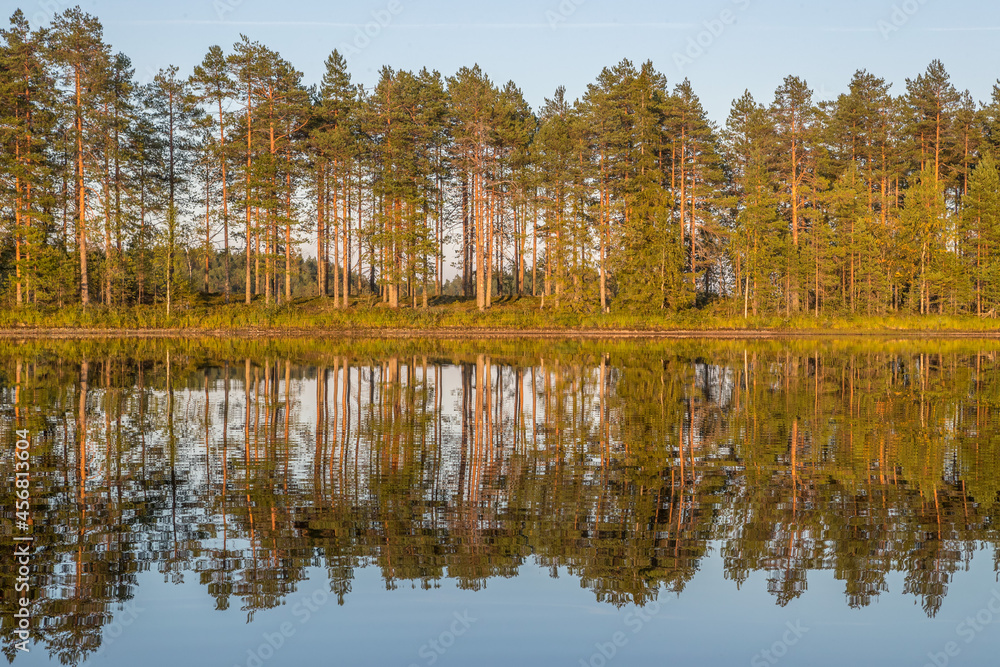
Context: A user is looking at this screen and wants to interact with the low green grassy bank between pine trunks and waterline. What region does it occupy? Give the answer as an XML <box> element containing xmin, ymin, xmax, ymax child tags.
<box><xmin>0</xmin><ymin>295</ymin><xmax>1000</xmax><ymax>334</ymax></box>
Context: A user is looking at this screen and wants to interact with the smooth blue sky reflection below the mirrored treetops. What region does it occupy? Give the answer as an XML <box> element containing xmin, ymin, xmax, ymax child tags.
<box><xmin>14</xmin><ymin>544</ymin><xmax>1000</xmax><ymax>667</ymax></box>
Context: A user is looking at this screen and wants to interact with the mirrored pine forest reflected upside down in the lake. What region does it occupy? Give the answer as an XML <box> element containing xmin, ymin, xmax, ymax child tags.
<box><xmin>0</xmin><ymin>341</ymin><xmax>1000</xmax><ymax>663</ymax></box>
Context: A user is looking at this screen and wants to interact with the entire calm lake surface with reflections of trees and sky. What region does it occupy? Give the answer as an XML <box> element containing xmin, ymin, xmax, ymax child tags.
<box><xmin>0</xmin><ymin>340</ymin><xmax>1000</xmax><ymax>667</ymax></box>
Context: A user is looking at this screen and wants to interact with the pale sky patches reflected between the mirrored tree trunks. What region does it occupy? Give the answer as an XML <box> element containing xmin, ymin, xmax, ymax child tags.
<box><xmin>68</xmin><ymin>359</ymin><xmax>960</xmax><ymax>498</ymax></box>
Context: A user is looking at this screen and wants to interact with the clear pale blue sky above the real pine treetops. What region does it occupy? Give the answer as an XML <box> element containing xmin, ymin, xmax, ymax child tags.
<box><xmin>11</xmin><ymin>0</ymin><xmax>1000</xmax><ymax>122</ymax></box>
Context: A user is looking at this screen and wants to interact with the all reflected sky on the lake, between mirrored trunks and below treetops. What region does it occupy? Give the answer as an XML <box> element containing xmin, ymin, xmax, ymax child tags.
<box><xmin>15</xmin><ymin>357</ymin><xmax>1000</xmax><ymax>667</ymax></box>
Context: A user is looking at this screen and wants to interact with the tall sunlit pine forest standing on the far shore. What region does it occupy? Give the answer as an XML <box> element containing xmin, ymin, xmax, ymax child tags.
<box><xmin>0</xmin><ymin>7</ymin><xmax>1000</xmax><ymax>318</ymax></box>
